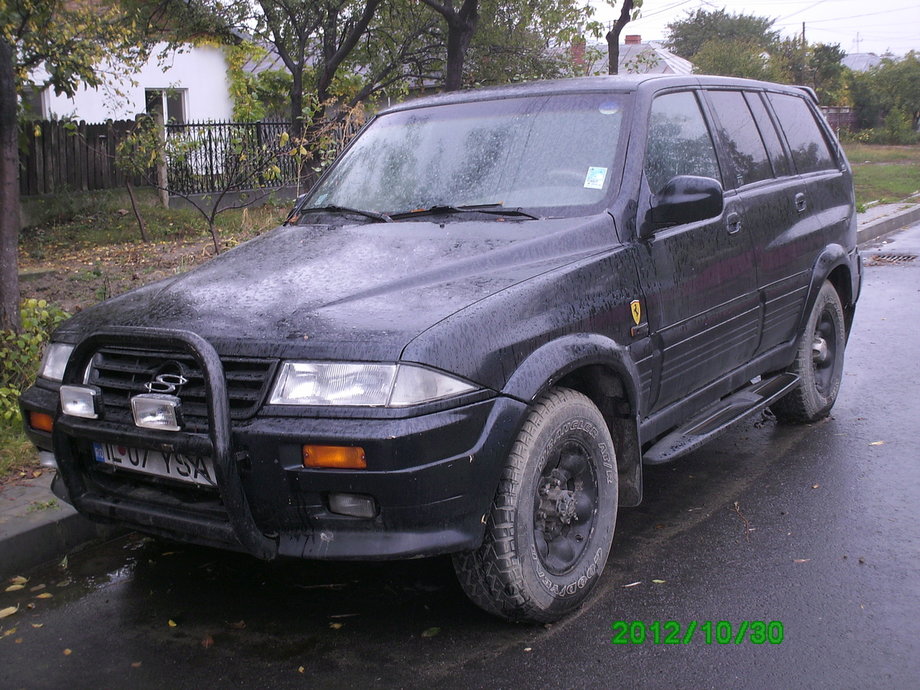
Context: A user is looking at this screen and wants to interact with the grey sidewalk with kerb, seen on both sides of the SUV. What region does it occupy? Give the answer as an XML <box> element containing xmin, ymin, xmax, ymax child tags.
<box><xmin>0</xmin><ymin>203</ymin><xmax>920</xmax><ymax>578</ymax></box>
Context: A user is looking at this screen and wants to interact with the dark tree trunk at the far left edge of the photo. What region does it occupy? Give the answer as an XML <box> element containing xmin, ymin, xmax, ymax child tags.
<box><xmin>0</xmin><ymin>35</ymin><xmax>20</xmax><ymax>332</ymax></box>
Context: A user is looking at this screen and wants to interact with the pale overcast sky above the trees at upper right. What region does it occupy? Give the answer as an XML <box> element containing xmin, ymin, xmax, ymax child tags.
<box><xmin>591</xmin><ymin>0</ymin><xmax>920</xmax><ymax>55</ymax></box>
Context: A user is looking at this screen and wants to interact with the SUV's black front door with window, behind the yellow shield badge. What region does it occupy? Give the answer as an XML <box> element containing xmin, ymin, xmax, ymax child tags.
<box><xmin>638</xmin><ymin>91</ymin><xmax>762</xmax><ymax>411</ymax></box>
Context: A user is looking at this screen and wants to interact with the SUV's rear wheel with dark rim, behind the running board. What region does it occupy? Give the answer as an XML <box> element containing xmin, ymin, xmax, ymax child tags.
<box><xmin>770</xmin><ymin>282</ymin><xmax>846</xmax><ymax>424</ymax></box>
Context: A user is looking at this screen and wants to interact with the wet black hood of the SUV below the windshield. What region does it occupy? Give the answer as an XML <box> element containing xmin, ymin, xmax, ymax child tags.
<box><xmin>58</xmin><ymin>214</ymin><xmax>616</xmax><ymax>361</ymax></box>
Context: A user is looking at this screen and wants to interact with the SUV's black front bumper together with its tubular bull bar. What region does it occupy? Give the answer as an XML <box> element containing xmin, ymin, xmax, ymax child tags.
<box><xmin>21</xmin><ymin>331</ymin><xmax>526</xmax><ymax>560</ymax></box>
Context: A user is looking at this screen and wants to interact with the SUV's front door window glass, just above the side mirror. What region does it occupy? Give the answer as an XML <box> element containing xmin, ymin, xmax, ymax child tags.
<box><xmin>645</xmin><ymin>91</ymin><xmax>721</xmax><ymax>193</ymax></box>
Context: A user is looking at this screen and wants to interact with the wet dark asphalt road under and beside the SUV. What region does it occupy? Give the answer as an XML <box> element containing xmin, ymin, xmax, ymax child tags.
<box><xmin>0</xmin><ymin>225</ymin><xmax>920</xmax><ymax>688</ymax></box>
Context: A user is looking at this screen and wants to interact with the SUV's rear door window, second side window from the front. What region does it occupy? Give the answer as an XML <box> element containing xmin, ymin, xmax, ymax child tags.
<box><xmin>708</xmin><ymin>91</ymin><xmax>773</xmax><ymax>187</ymax></box>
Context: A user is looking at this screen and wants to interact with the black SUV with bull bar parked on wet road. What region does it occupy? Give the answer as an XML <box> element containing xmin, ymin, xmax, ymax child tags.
<box><xmin>22</xmin><ymin>76</ymin><xmax>860</xmax><ymax>621</ymax></box>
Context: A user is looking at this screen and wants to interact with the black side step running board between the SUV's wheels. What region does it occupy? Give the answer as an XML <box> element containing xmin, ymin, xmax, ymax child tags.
<box><xmin>642</xmin><ymin>374</ymin><xmax>799</xmax><ymax>465</ymax></box>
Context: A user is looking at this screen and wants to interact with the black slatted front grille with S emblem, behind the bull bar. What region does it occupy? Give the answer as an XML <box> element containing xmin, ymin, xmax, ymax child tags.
<box><xmin>88</xmin><ymin>347</ymin><xmax>276</xmax><ymax>422</ymax></box>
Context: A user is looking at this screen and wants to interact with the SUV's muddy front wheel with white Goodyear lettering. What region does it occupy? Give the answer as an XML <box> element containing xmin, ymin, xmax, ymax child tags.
<box><xmin>453</xmin><ymin>388</ymin><xmax>617</xmax><ymax>623</ymax></box>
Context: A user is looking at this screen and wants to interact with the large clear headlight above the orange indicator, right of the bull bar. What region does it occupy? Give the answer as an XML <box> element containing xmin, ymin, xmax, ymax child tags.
<box><xmin>269</xmin><ymin>362</ymin><xmax>476</xmax><ymax>407</ymax></box>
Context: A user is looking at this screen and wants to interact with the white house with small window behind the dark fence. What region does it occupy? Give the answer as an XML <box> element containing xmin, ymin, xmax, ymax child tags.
<box><xmin>26</xmin><ymin>44</ymin><xmax>233</xmax><ymax>124</ymax></box>
